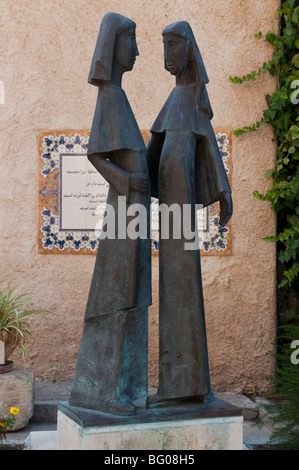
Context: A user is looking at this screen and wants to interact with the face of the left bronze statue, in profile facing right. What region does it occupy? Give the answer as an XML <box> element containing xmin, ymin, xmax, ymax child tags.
<box><xmin>114</xmin><ymin>27</ymin><xmax>139</xmax><ymax>72</ymax></box>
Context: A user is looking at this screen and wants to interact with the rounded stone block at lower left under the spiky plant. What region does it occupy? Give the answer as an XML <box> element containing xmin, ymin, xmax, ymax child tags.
<box><xmin>0</xmin><ymin>368</ymin><xmax>35</xmax><ymax>431</ymax></box>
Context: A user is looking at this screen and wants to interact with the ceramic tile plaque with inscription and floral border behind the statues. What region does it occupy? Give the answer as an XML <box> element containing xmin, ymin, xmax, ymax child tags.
<box><xmin>38</xmin><ymin>129</ymin><xmax>232</xmax><ymax>256</ymax></box>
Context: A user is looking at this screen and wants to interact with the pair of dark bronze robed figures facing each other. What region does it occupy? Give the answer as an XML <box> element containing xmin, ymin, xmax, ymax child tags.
<box><xmin>70</xmin><ymin>13</ymin><xmax>232</xmax><ymax>415</ymax></box>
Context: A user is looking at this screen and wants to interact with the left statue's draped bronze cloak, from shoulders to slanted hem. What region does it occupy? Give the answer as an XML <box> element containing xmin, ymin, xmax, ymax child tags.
<box><xmin>86</xmin><ymin>85</ymin><xmax>151</xmax><ymax>318</ymax></box>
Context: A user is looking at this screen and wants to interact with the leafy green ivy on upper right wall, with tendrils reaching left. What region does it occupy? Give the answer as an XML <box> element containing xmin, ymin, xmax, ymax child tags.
<box><xmin>230</xmin><ymin>0</ymin><xmax>299</xmax><ymax>287</ymax></box>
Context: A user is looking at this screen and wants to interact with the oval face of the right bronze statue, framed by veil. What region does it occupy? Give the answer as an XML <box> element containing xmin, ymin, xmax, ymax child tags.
<box><xmin>163</xmin><ymin>33</ymin><xmax>190</xmax><ymax>76</ymax></box>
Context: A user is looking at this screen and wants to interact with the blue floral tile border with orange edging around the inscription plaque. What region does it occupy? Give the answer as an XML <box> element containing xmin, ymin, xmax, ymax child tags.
<box><xmin>38</xmin><ymin>129</ymin><xmax>232</xmax><ymax>256</ymax></box>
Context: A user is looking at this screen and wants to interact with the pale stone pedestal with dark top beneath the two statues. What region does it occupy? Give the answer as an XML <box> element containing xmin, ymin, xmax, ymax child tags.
<box><xmin>58</xmin><ymin>400</ymin><xmax>243</xmax><ymax>451</ymax></box>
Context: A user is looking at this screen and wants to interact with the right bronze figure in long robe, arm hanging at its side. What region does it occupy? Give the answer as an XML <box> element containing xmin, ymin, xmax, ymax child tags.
<box><xmin>147</xmin><ymin>21</ymin><xmax>232</xmax><ymax>406</ymax></box>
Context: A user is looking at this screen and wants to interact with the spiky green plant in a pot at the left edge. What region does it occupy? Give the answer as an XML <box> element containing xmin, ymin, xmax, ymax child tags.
<box><xmin>0</xmin><ymin>286</ymin><xmax>50</xmax><ymax>373</ymax></box>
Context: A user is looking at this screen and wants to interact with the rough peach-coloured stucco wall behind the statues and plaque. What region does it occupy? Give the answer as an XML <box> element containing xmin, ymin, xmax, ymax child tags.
<box><xmin>0</xmin><ymin>0</ymin><xmax>279</xmax><ymax>392</ymax></box>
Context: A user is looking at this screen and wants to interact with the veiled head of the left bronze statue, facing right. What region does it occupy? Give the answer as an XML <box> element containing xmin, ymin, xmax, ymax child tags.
<box><xmin>88</xmin><ymin>13</ymin><xmax>139</xmax><ymax>86</ymax></box>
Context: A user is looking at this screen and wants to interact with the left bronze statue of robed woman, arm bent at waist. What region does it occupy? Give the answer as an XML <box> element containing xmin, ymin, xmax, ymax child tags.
<box><xmin>69</xmin><ymin>13</ymin><xmax>151</xmax><ymax>415</ymax></box>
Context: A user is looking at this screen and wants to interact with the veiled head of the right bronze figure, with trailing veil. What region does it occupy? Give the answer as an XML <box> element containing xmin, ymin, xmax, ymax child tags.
<box><xmin>162</xmin><ymin>21</ymin><xmax>213</xmax><ymax>119</ymax></box>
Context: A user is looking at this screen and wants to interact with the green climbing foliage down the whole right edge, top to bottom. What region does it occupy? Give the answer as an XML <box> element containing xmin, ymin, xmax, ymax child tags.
<box><xmin>230</xmin><ymin>0</ymin><xmax>299</xmax><ymax>450</ymax></box>
